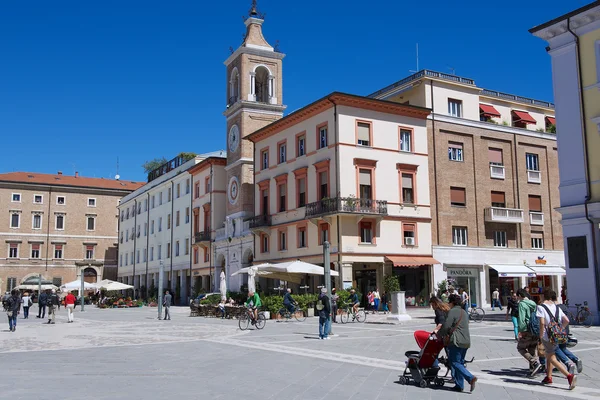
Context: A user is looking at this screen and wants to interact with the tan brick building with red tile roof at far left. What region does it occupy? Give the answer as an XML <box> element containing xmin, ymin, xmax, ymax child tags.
<box><xmin>0</xmin><ymin>172</ymin><xmax>141</xmax><ymax>290</ymax></box>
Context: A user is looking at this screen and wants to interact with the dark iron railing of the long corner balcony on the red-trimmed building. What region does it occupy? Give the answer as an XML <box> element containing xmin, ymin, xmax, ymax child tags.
<box><xmin>306</xmin><ymin>197</ymin><xmax>387</xmax><ymax>217</ymax></box>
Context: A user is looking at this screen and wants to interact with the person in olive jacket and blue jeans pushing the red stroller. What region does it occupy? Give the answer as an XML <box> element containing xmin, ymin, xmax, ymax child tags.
<box><xmin>438</xmin><ymin>294</ymin><xmax>477</xmax><ymax>392</ymax></box>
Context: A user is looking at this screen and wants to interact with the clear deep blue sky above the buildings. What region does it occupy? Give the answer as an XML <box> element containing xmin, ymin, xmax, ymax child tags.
<box><xmin>0</xmin><ymin>0</ymin><xmax>589</xmax><ymax>180</ymax></box>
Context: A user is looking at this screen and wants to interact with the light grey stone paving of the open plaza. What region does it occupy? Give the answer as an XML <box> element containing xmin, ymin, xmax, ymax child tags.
<box><xmin>0</xmin><ymin>306</ymin><xmax>600</xmax><ymax>400</ymax></box>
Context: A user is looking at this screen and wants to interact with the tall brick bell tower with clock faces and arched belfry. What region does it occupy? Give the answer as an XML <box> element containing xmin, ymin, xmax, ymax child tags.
<box><xmin>223</xmin><ymin>0</ymin><xmax>285</xmax><ymax>220</ymax></box>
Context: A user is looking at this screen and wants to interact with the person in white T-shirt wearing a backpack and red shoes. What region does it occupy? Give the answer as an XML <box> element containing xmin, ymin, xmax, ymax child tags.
<box><xmin>536</xmin><ymin>288</ymin><xmax>577</xmax><ymax>390</ymax></box>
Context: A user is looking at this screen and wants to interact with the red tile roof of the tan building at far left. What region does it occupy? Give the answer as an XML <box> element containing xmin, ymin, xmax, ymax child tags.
<box><xmin>0</xmin><ymin>172</ymin><xmax>145</xmax><ymax>192</ymax></box>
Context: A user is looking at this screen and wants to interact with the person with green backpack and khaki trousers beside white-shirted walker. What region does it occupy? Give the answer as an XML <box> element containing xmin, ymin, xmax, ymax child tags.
<box><xmin>517</xmin><ymin>289</ymin><xmax>542</xmax><ymax>377</ymax></box>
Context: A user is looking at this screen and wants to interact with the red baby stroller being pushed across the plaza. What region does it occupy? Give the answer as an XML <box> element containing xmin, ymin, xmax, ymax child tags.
<box><xmin>398</xmin><ymin>331</ymin><xmax>445</xmax><ymax>388</ymax></box>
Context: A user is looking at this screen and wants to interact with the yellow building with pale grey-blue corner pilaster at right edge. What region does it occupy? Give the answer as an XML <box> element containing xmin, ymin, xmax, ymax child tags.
<box><xmin>530</xmin><ymin>1</ymin><xmax>600</xmax><ymax>318</ymax></box>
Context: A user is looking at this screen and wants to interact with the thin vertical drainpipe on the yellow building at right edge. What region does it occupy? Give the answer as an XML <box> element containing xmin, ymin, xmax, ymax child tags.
<box><xmin>567</xmin><ymin>17</ymin><xmax>600</xmax><ymax>310</ymax></box>
